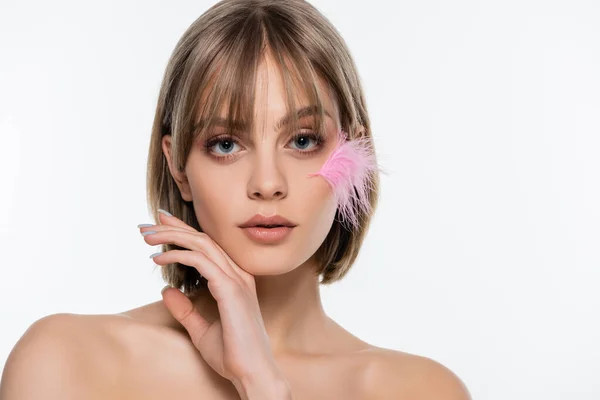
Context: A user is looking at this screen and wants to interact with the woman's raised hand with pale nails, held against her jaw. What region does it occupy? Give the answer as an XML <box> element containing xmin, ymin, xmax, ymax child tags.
<box><xmin>140</xmin><ymin>213</ymin><xmax>287</xmax><ymax>398</ymax></box>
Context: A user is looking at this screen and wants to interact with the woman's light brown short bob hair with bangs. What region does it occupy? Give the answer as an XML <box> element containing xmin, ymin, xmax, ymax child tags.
<box><xmin>147</xmin><ymin>0</ymin><xmax>379</xmax><ymax>297</ymax></box>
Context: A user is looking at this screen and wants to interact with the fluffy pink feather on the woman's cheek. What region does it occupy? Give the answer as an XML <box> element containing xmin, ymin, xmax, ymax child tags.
<box><xmin>309</xmin><ymin>130</ymin><xmax>379</xmax><ymax>227</ymax></box>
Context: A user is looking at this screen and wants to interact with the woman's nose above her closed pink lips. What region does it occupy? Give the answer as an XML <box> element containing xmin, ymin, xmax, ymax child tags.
<box><xmin>248</xmin><ymin>149</ymin><xmax>288</xmax><ymax>200</ymax></box>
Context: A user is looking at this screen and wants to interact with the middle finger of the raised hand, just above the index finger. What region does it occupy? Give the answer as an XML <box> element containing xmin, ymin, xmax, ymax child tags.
<box><xmin>144</xmin><ymin>225</ymin><xmax>241</xmax><ymax>278</ymax></box>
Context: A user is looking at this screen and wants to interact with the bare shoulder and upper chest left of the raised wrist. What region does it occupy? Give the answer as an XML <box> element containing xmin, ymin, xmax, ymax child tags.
<box><xmin>0</xmin><ymin>307</ymin><xmax>235</xmax><ymax>400</ymax></box>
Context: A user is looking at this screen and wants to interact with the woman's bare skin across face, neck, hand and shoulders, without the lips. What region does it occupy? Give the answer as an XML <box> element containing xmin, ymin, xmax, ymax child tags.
<box><xmin>0</xmin><ymin>51</ymin><xmax>470</xmax><ymax>400</ymax></box>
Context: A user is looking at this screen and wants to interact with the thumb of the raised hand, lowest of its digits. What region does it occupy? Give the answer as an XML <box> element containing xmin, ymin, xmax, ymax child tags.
<box><xmin>162</xmin><ymin>288</ymin><xmax>210</xmax><ymax>347</ymax></box>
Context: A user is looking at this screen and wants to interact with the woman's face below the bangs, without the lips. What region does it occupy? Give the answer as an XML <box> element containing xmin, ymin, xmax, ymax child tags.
<box><xmin>163</xmin><ymin>58</ymin><xmax>339</xmax><ymax>275</ymax></box>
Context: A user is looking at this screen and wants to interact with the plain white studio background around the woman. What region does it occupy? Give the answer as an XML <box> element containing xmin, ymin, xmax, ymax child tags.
<box><xmin>0</xmin><ymin>0</ymin><xmax>600</xmax><ymax>400</ymax></box>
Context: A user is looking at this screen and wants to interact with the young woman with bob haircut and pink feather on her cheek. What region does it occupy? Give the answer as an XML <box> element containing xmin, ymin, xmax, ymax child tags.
<box><xmin>0</xmin><ymin>0</ymin><xmax>469</xmax><ymax>400</ymax></box>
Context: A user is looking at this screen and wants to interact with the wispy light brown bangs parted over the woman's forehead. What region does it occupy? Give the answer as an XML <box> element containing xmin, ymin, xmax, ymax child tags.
<box><xmin>183</xmin><ymin>18</ymin><xmax>334</xmax><ymax>148</ymax></box>
